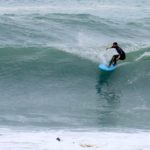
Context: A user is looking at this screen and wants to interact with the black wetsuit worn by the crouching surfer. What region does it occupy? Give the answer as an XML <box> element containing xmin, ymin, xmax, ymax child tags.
<box><xmin>109</xmin><ymin>46</ymin><xmax>126</xmax><ymax>66</ymax></box>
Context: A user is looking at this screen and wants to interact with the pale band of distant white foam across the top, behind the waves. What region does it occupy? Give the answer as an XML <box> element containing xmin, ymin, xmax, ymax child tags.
<box><xmin>0</xmin><ymin>1</ymin><xmax>149</xmax><ymax>15</ymax></box>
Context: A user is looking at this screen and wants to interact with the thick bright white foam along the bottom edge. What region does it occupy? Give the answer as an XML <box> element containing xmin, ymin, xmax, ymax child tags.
<box><xmin>0</xmin><ymin>129</ymin><xmax>150</xmax><ymax>150</ymax></box>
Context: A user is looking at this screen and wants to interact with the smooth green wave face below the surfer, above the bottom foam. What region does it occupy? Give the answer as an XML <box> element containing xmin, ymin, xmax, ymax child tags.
<box><xmin>0</xmin><ymin>47</ymin><xmax>150</xmax><ymax>129</ymax></box>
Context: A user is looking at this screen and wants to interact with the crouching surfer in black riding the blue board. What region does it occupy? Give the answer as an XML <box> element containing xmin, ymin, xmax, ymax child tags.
<box><xmin>106</xmin><ymin>42</ymin><xmax>126</xmax><ymax>67</ymax></box>
